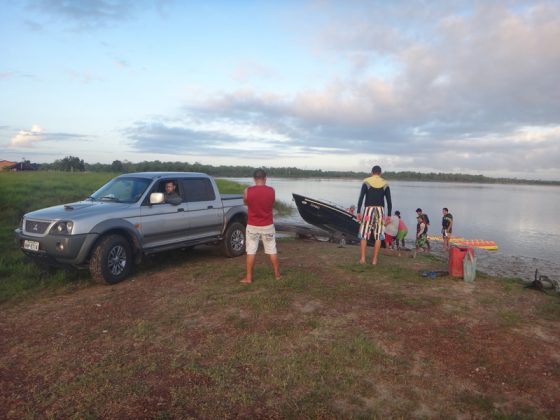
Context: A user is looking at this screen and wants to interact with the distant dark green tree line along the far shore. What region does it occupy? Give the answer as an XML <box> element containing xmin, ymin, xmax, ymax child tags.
<box><xmin>5</xmin><ymin>156</ymin><xmax>560</xmax><ymax>186</ymax></box>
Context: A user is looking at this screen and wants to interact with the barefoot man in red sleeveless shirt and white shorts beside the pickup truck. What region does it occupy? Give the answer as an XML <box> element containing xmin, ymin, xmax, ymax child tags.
<box><xmin>241</xmin><ymin>169</ymin><xmax>280</xmax><ymax>283</ymax></box>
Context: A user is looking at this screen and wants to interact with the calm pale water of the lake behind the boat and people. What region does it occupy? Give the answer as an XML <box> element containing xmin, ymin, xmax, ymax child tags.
<box><xmin>225</xmin><ymin>178</ymin><xmax>560</xmax><ymax>280</ymax></box>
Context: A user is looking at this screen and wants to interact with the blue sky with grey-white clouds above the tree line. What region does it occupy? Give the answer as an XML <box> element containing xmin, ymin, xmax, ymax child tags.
<box><xmin>0</xmin><ymin>0</ymin><xmax>560</xmax><ymax>180</ymax></box>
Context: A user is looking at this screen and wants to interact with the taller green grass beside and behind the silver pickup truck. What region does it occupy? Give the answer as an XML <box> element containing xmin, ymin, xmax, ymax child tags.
<box><xmin>0</xmin><ymin>172</ymin><xmax>270</xmax><ymax>302</ymax></box>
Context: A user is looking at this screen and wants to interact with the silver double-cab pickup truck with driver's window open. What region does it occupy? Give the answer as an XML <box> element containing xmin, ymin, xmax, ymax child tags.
<box><xmin>15</xmin><ymin>172</ymin><xmax>247</xmax><ymax>284</ymax></box>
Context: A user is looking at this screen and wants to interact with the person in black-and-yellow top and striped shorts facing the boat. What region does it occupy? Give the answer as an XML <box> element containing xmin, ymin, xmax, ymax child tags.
<box><xmin>358</xmin><ymin>165</ymin><xmax>392</xmax><ymax>265</ymax></box>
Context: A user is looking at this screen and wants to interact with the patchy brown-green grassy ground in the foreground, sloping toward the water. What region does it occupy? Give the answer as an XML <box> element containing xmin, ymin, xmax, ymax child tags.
<box><xmin>0</xmin><ymin>239</ymin><xmax>560</xmax><ymax>419</ymax></box>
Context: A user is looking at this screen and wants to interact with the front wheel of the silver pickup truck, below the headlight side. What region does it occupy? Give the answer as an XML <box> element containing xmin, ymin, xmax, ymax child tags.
<box><xmin>89</xmin><ymin>235</ymin><xmax>133</xmax><ymax>284</ymax></box>
